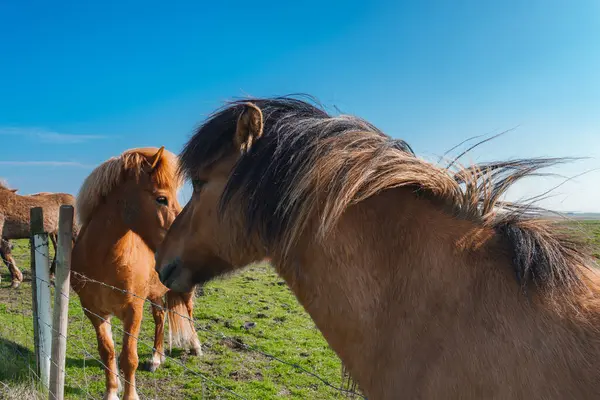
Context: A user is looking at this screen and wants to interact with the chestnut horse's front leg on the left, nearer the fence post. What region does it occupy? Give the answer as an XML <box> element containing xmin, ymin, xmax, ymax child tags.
<box><xmin>85</xmin><ymin>311</ymin><xmax>121</xmax><ymax>400</ymax></box>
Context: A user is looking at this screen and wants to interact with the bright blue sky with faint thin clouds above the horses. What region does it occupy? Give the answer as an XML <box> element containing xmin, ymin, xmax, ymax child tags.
<box><xmin>0</xmin><ymin>0</ymin><xmax>600</xmax><ymax>211</ymax></box>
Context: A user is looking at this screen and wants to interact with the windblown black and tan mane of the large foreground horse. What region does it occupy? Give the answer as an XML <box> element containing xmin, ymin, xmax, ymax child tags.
<box><xmin>180</xmin><ymin>97</ymin><xmax>595</xmax><ymax>296</ymax></box>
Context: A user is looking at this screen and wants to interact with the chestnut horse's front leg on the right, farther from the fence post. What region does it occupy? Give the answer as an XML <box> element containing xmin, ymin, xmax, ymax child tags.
<box><xmin>119</xmin><ymin>299</ymin><xmax>144</xmax><ymax>400</ymax></box>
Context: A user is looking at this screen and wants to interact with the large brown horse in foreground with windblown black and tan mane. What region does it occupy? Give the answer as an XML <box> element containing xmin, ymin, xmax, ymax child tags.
<box><xmin>157</xmin><ymin>98</ymin><xmax>600</xmax><ymax>400</ymax></box>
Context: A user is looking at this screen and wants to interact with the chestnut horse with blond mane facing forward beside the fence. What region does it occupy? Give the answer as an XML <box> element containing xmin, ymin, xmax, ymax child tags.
<box><xmin>71</xmin><ymin>147</ymin><xmax>202</xmax><ymax>399</ymax></box>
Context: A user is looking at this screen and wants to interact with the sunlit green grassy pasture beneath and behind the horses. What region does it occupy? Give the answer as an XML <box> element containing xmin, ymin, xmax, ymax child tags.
<box><xmin>0</xmin><ymin>221</ymin><xmax>600</xmax><ymax>400</ymax></box>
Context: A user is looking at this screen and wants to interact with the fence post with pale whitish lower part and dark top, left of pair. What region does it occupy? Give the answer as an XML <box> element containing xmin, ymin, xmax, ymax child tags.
<box><xmin>30</xmin><ymin>207</ymin><xmax>52</xmax><ymax>388</ymax></box>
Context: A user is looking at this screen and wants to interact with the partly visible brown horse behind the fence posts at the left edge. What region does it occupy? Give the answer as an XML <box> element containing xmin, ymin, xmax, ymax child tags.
<box><xmin>0</xmin><ymin>182</ymin><xmax>79</xmax><ymax>288</ymax></box>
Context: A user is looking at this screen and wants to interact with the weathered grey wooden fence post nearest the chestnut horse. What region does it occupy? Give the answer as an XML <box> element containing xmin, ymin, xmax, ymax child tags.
<box><xmin>49</xmin><ymin>205</ymin><xmax>74</xmax><ymax>400</ymax></box>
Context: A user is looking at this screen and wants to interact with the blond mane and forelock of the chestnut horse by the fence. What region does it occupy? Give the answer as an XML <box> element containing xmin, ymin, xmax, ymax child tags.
<box><xmin>76</xmin><ymin>147</ymin><xmax>182</xmax><ymax>226</ymax></box>
